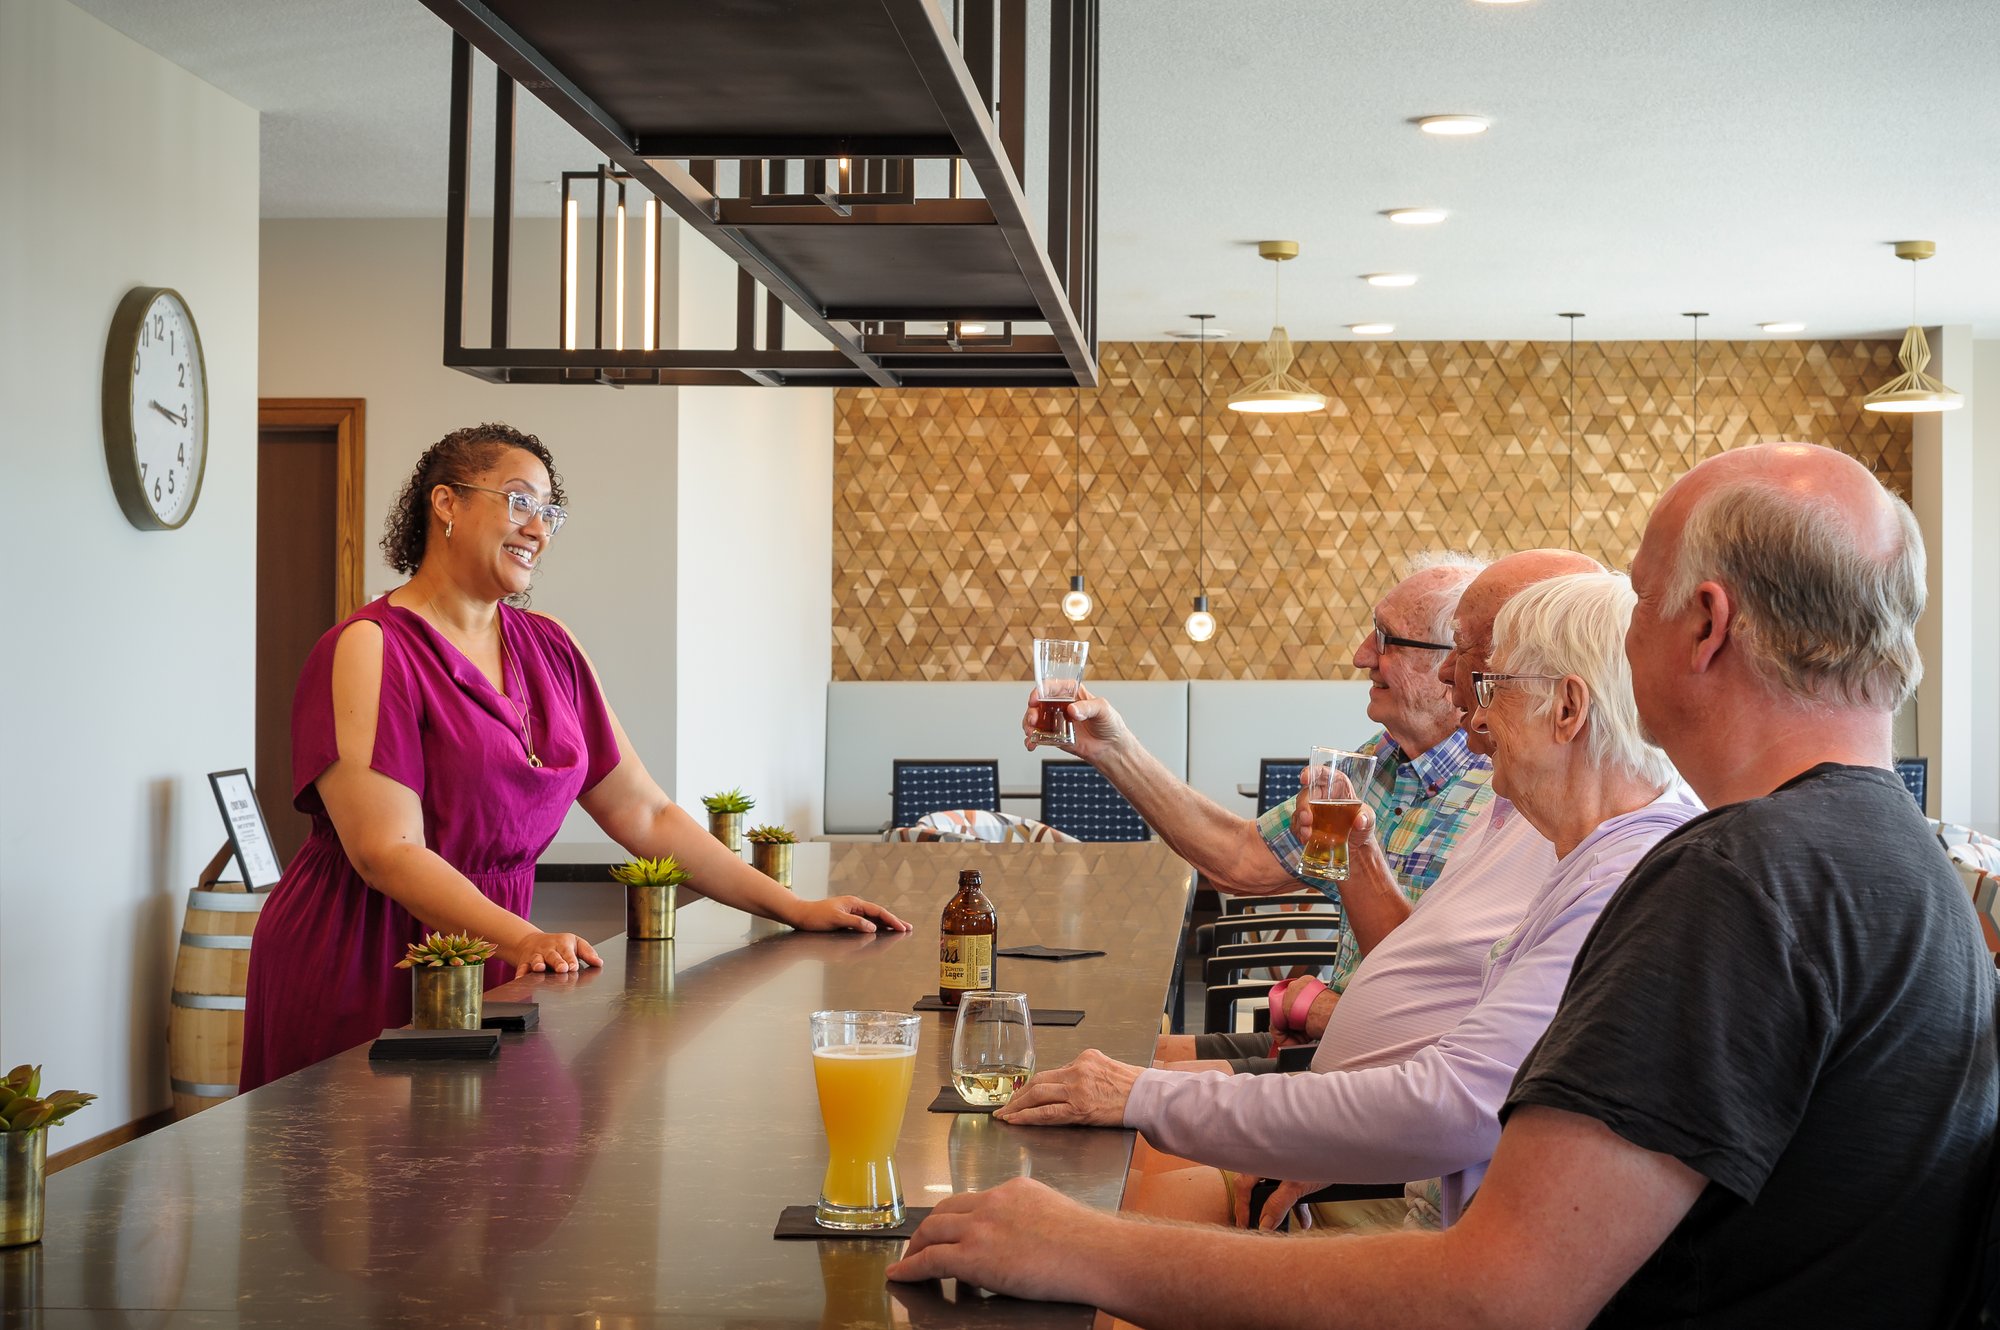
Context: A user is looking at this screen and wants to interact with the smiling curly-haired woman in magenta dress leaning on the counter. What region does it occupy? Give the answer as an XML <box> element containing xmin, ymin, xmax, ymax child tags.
<box><xmin>242</xmin><ymin>424</ymin><xmax>908</xmax><ymax>1090</ymax></box>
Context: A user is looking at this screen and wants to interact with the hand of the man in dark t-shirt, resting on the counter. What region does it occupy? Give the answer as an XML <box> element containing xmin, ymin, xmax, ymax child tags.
<box><xmin>886</xmin><ymin>1178</ymin><xmax>1118</xmax><ymax>1302</ymax></box>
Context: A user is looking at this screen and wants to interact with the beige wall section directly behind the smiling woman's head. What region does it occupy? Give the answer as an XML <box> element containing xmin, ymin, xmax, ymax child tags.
<box><xmin>260</xmin><ymin>220</ymin><xmax>680</xmax><ymax>840</ymax></box>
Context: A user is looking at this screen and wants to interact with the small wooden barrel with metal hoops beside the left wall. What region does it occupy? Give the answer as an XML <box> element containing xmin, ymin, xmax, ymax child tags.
<box><xmin>166</xmin><ymin>882</ymin><xmax>264</xmax><ymax>1118</ymax></box>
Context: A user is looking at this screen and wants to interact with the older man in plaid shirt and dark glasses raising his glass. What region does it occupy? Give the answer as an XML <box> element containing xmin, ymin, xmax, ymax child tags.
<box><xmin>1022</xmin><ymin>554</ymin><xmax>1492</xmax><ymax>1070</ymax></box>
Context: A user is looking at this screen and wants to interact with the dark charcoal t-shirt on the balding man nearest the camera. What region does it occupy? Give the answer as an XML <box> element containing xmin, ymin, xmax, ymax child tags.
<box><xmin>1502</xmin><ymin>764</ymin><xmax>2000</xmax><ymax>1328</ymax></box>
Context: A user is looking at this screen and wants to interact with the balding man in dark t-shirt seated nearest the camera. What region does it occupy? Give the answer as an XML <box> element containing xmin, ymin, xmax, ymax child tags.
<box><xmin>890</xmin><ymin>444</ymin><xmax>2000</xmax><ymax>1330</ymax></box>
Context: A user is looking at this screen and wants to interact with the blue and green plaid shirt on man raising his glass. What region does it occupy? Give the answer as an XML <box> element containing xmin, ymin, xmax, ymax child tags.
<box><xmin>1258</xmin><ymin>730</ymin><xmax>1494</xmax><ymax>992</ymax></box>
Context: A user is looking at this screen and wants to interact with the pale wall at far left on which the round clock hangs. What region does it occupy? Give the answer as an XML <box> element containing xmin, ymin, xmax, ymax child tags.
<box><xmin>0</xmin><ymin>0</ymin><xmax>258</xmax><ymax>1148</ymax></box>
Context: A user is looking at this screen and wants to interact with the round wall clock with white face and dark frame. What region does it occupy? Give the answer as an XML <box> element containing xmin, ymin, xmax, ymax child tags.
<box><xmin>104</xmin><ymin>286</ymin><xmax>208</xmax><ymax>530</ymax></box>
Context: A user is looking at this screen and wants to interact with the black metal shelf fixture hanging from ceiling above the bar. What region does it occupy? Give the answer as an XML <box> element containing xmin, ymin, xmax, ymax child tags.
<box><xmin>424</xmin><ymin>0</ymin><xmax>1098</xmax><ymax>388</ymax></box>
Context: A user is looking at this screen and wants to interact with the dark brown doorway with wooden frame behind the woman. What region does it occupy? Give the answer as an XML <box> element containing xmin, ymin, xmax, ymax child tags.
<box><xmin>256</xmin><ymin>398</ymin><xmax>366</xmax><ymax>864</ymax></box>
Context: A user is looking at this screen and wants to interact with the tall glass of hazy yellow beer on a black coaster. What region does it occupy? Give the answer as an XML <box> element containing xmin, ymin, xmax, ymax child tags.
<box><xmin>812</xmin><ymin>1012</ymin><xmax>920</xmax><ymax>1228</ymax></box>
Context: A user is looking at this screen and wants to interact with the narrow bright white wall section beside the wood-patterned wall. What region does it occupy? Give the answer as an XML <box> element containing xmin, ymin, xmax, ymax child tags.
<box><xmin>676</xmin><ymin>230</ymin><xmax>834</xmax><ymax>836</ymax></box>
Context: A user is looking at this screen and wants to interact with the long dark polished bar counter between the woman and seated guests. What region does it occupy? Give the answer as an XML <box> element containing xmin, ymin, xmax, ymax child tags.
<box><xmin>0</xmin><ymin>844</ymin><xmax>1190</xmax><ymax>1330</ymax></box>
